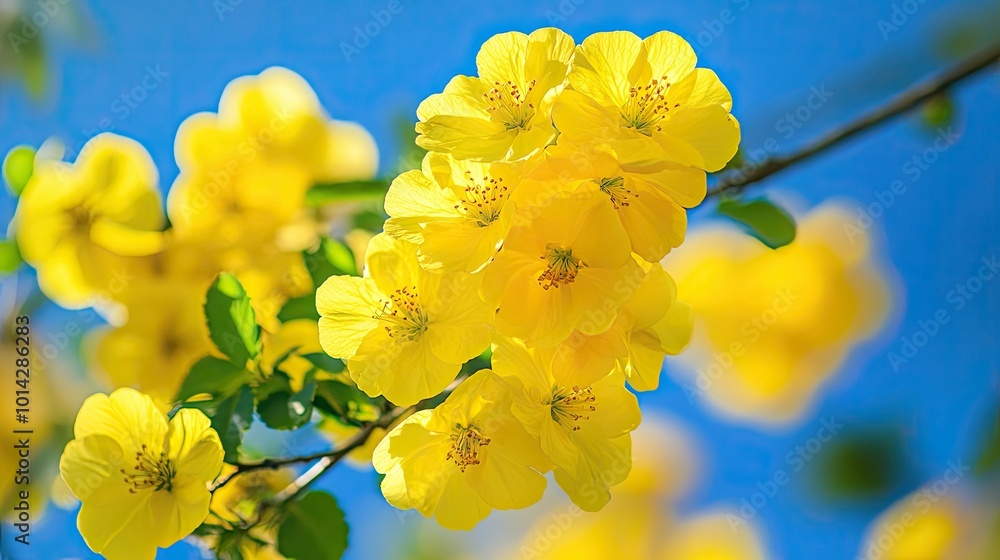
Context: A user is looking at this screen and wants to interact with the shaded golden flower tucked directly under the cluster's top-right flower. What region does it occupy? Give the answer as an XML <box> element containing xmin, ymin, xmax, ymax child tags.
<box><xmin>514</xmin><ymin>142</ymin><xmax>705</xmax><ymax>262</ymax></box>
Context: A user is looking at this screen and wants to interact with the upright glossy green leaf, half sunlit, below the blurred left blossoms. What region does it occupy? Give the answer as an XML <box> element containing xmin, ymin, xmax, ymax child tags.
<box><xmin>205</xmin><ymin>272</ymin><xmax>261</xmax><ymax>367</ymax></box>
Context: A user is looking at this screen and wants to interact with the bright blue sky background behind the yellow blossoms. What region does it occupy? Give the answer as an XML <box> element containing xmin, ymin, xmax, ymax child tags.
<box><xmin>0</xmin><ymin>0</ymin><xmax>1000</xmax><ymax>560</ymax></box>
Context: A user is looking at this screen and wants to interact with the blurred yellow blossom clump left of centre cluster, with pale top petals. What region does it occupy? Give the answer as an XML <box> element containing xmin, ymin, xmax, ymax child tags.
<box><xmin>168</xmin><ymin>68</ymin><xmax>378</xmax><ymax>255</ymax></box>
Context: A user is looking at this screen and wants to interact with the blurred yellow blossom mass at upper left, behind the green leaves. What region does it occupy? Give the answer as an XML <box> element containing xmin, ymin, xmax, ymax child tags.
<box><xmin>15</xmin><ymin>68</ymin><xmax>378</xmax><ymax>403</ymax></box>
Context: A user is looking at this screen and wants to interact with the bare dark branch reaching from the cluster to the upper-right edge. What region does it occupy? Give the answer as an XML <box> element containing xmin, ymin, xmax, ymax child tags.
<box><xmin>707</xmin><ymin>45</ymin><xmax>1000</xmax><ymax>196</ymax></box>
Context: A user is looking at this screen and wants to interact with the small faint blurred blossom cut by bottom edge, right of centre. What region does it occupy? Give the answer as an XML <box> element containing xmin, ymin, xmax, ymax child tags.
<box><xmin>655</xmin><ymin>512</ymin><xmax>766</xmax><ymax>560</ymax></box>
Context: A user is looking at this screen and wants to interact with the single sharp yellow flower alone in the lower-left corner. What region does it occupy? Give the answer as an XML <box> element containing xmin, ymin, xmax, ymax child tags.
<box><xmin>59</xmin><ymin>389</ymin><xmax>223</xmax><ymax>560</ymax></box>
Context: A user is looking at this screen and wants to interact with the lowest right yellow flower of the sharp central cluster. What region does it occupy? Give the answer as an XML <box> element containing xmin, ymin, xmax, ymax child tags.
<box><xmin>493</xmin><ymin>337</ymin><xmax>641</xmax><ymax>511</ymax></box>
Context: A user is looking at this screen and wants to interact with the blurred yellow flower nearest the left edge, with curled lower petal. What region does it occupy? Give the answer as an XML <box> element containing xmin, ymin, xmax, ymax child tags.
<box><xmin>14</xmin><ymin>134</ymin><xmax>164</xmax><ymax>308</ymax></box>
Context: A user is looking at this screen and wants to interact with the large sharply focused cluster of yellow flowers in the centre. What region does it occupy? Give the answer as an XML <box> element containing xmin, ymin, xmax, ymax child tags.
<box><xmin>317</xmin><ymin>28</ymin><xmax>739</xmax><ymax>529</ymax></box>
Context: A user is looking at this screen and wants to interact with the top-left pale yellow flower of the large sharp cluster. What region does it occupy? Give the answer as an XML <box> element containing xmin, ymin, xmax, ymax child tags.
<box><xmin>417</xmin><ymin>27</ymin><xmax>574</xmax><ymax>161</ymax></box>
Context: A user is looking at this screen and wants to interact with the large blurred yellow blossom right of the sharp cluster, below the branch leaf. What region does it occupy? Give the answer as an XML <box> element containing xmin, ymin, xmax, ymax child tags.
<box><xmin>665</xmin><ymin>205</ymin><xmax>889</xmax><ymax>423</ymax></box>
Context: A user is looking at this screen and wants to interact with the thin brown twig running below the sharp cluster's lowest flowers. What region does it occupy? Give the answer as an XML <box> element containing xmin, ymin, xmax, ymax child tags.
<box><xmin>211</xmin><ymin>376</ymin><xmax>466</xmax><ymax>490</ymax></box>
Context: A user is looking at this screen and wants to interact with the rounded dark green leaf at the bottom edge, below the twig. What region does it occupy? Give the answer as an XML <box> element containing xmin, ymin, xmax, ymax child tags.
<box><xmin>278</xmin><ymin>492</ymin><xmax>347</xmax><ymax>560</ymax></box>
